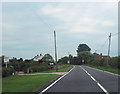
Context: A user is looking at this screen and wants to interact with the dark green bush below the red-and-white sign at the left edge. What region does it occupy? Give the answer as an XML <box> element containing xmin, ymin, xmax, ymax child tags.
<box><xmin>2</xmin><ymin>67</ymin><xmax>15</xmax><ymax>77</ymax></box>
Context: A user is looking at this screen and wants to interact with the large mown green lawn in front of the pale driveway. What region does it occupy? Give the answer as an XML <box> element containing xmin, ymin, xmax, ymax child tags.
<box><xmin>2</xmin><ymin>74</ymin><xmax>58</xmax><ymax>92</ymax></box>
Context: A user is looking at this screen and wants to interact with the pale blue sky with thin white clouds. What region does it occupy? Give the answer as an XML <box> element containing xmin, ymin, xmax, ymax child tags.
<box><xmin>2</xmin><ymin>2</ymin><xmax>118</xmax><ymax>59</ymax></box>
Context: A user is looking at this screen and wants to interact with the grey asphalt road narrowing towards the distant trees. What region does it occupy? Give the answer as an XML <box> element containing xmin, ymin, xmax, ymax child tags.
<box><xmin>43</xmin><ymin>65</ymin><xmax>119</xmax><ymax>94</ymax></box>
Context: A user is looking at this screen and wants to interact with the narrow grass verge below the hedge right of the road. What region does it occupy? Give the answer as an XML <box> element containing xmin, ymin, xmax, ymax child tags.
<box><xmin>86</xmin><ymin>65</ymin><xmax>120</xmax><ymax>74</ymax></box>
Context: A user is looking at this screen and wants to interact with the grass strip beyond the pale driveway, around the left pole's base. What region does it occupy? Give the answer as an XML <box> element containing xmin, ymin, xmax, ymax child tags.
<box><xmin>34</xmin><ymin>65</ymin><xmax>73</xmax><ymax>73</ymax></box>
